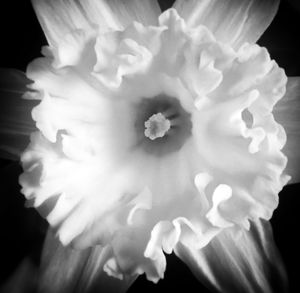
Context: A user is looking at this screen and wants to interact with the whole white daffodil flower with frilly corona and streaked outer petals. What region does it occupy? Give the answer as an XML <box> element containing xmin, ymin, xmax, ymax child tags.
<box><xmin>0</xmin><ymin>0</ymin><xmax>299</xmax><ymax>293</ymax></box>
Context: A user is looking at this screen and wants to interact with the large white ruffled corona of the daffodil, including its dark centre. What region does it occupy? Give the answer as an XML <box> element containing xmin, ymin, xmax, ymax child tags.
<box><xmin>20</xmin><ymin>9</ymin><xmax>289</xmax><ymax>282</ymax></box>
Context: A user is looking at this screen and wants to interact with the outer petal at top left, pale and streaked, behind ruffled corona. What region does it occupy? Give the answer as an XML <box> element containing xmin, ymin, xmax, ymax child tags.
<box><xmin>32</xmin><ymin>0</ymin><xmax>160</xmax><ymax>47</ymax></box>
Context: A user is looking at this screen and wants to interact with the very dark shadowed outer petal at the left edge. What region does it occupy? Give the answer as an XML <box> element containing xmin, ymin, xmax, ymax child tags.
<box><xmin>0</xmin><ymin>69</ymin><xmax>37</xmax><ymax>160</ymax></box>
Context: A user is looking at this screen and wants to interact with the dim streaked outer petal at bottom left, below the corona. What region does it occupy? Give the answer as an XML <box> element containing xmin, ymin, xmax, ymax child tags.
<box><xmin>38</xmin><ymin>231</ymin><xmax>135</xmax><ymax>293</ymax></box>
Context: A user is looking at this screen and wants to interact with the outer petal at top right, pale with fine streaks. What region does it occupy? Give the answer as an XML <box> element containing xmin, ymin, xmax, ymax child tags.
<box><xmin>174</xmin><ymin>0</ymin><xmax>279</xmax><ymax>48</ymax></box>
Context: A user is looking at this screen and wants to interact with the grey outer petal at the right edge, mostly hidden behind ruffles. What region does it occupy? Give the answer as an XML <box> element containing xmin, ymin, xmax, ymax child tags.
<box><xmin>273</xmin><ymin>77</ymin><xmax>300</xmax><ymax>183</ymax></box>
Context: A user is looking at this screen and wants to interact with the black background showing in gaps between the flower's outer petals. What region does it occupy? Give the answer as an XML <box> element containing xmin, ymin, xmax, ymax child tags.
<box><xmin>0</xmin><ymin>0</ymin><xmax>300</xmax><ymax>293</ymax></box>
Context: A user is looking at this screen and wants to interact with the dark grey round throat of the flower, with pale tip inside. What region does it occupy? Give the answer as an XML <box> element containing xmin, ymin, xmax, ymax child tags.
<box><xmin>134</xmin><ymin>94</ymin><xmax>192</xmax><ymax>157</ymax></box>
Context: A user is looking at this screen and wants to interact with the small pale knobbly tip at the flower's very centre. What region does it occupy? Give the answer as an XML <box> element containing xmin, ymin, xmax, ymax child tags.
<box><xmin>144</xmin><ymin>113</ymin><xmax>171</xmax><ymax>140</ymax></box>
